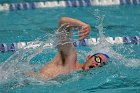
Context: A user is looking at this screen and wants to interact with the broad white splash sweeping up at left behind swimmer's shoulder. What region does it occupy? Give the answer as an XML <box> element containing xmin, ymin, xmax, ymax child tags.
<box><xmin>0</xmin><ymin>34</ymin><xmax>54</xmax><ymax>85</ymax></box>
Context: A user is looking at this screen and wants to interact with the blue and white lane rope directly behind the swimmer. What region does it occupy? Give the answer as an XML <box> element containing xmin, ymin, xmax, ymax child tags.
<box><xmin>0</xmin><ymin>36</ymin><xmax>140</xmax><ymax>52</ymax></box>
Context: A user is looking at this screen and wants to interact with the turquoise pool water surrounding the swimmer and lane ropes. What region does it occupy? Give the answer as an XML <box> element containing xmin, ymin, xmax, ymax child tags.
<box><xmin>0</xmin><ymin>5</ymin><xmax>140</xmax><ymax>93</ymax></box>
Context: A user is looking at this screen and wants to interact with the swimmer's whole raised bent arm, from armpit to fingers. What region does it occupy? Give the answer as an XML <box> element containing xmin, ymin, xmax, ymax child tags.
<box><xmin>57</xmin><ymin>17</ymin><xmax>90</xmax><ymax>67</ymax></box>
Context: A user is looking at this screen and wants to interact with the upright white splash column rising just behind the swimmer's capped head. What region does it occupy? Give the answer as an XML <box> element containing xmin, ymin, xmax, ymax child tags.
<box><xmin>89</xmin><ymin>16</ymin><xmax>123</xmax><ymax>60</ymax></box>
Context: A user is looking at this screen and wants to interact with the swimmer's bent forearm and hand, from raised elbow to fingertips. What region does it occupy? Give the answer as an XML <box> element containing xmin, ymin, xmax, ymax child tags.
<box><xmin>59</xmin><ymin>17</ymin><xmax>91</xmax><ymax>40</ymax></box>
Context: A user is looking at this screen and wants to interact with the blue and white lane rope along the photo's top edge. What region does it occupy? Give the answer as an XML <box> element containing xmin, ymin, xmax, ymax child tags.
<box><xmin>0</xmin><ymin>0</ymin><xmax>140</xmax><ymax>11</ymax></box>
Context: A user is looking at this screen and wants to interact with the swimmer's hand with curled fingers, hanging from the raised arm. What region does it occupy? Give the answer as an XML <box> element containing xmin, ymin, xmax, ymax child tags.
<box><xmin>79</xmin><ymin>24</ymin><xmax>91</xmax><ymax>40</ymax></box>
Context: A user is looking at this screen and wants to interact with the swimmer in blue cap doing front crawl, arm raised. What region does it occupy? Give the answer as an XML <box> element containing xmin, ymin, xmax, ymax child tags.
<box><xmin>27</xmin><ymin>17</ymin><xmax>109</xmax><ymax>79</ymax></box>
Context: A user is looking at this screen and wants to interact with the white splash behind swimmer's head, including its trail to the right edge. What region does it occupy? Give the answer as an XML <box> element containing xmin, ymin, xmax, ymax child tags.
<box><xmin>91</xmin><ymin>16</ymin><xmax>140</xmax><ymax>67</ymax></box>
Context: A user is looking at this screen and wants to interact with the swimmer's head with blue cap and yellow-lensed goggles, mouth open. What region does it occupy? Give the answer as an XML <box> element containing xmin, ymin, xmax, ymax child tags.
<box><xmin>82</xmin><ymin>53</ymin><xmax>109</xmax><ymax>70</ymax></box>
